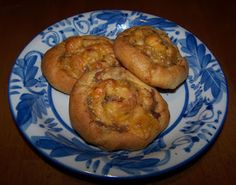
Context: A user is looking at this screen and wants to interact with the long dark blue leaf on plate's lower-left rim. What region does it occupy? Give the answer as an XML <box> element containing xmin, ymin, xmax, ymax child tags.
<box><xmin>31</xmin><ymin>131</ymin><xmax>109</xmax><ymax>172</ymax></box>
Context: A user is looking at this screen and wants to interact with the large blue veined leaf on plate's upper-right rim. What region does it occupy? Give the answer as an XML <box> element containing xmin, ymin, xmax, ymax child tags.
<box><xmin>179</xmin><ymin>32</ymin><xmax>226</xmax><ymax>101</ymax></box>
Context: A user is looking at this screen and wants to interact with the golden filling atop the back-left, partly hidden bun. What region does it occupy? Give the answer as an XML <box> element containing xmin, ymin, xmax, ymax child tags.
<box><xmin>60</xmin><ymin>37</ymin><xmax>119</xmax><ymax>79</ymax></box>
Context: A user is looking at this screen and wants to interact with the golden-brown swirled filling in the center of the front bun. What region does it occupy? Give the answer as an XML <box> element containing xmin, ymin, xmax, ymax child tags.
<box><xmin>87</xmin><ymin>79</ymin><xmax>159</xmax><ymax>139</ymax></box>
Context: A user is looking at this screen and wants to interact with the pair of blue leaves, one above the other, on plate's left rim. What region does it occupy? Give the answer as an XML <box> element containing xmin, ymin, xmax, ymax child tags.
<box><xmin>10</xmin><ymin>51</ymin><xmax>49</xmax><ymax>129</ymax></box>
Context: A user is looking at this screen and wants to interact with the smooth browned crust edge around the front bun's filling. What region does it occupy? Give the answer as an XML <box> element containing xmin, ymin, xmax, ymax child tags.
<box><xmin>69</xmin><ymin>69</ymin><xmax>170</xmax><ymax>151</ymax></box>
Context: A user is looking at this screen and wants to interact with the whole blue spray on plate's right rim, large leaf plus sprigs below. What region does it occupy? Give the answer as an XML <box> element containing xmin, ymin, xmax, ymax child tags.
<box><xmin>179</xmin><ymin>32</ymin><xmax>226</xmax><ymax>142</ymax></box>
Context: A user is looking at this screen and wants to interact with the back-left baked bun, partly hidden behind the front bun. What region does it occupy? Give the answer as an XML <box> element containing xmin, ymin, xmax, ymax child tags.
<box><xmin>41</xmin><ymin>35</ymin><xmax>120</xmax><ymax>94</ymax></box>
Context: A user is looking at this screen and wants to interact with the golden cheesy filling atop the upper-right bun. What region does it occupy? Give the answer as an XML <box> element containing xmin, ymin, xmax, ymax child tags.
<box><xmin>125</xmin><ymin>27</ymin><xmax>182</xmax><ymax>67</ymax></box>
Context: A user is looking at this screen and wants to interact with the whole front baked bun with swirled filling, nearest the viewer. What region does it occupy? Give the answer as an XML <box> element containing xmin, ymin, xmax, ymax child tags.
<box><xmin>69</xmin><ymin>67</ymin><xmax>170</xmax><ymax>151</ymax></box>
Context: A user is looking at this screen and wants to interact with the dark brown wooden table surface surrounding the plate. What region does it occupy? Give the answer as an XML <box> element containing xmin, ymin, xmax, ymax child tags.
<box><xmin>0</xmin><ymin>0</ymin><xmax>236</xmax><ymax>185</ymax></box>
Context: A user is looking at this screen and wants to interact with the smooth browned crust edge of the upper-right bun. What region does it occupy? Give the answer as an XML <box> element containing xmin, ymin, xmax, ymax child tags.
<box><xmin>114</xmin><ymin>36</ymin><xmax>188</xmax><ymax>89</ymax></box>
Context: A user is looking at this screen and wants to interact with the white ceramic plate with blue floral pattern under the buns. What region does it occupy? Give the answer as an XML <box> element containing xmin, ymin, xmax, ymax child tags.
<box><xmin>8</xmin><ymin>10</ymin><xmax>228</xmax><ymax>179</ymax></box>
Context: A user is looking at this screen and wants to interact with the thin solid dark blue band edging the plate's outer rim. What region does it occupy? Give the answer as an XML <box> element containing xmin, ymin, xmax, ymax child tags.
<box><xmin>7</xmin><ymin>9</ymin><xmax>229</xmax><ymax>180</ymax></box>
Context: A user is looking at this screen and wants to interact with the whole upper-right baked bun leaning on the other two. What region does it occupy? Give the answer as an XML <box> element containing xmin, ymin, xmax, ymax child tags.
<box><xmin>114</xmin><ymin>26</ymin><xmax>188</xmax><ymax>89</ymax></box>
